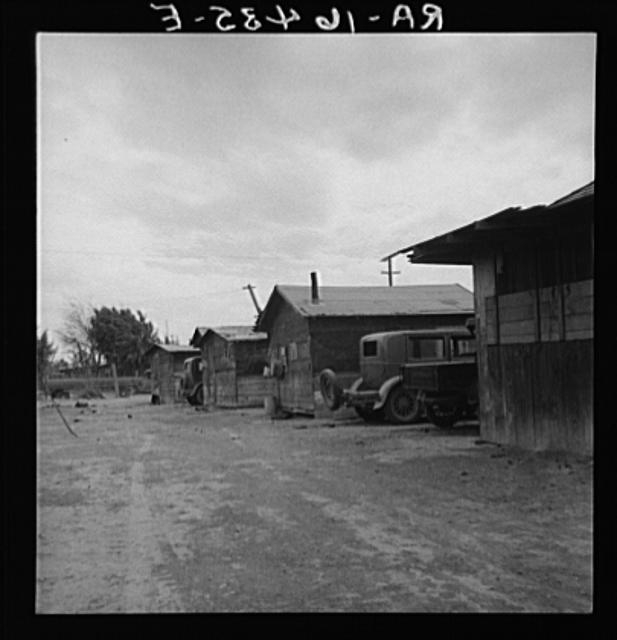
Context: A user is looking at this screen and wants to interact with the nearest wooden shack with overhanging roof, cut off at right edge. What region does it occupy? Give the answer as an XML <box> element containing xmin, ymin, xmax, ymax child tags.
<box><xmin>394</xmin><ymin>182</ymin><xmax>594</xmax><ymax>453</ymax></box>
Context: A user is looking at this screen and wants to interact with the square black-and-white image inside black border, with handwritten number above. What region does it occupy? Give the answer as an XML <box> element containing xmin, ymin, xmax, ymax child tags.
<box><xmin>28</xmin><ymin>2</ymin><xmax>598</xmax><ymax>614</ymax></box>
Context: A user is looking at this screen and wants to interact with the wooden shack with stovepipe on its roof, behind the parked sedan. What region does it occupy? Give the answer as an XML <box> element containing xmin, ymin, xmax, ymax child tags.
<box><xmin>256</xmin><ymin>279</ymin><xmax>473</xmax><ymax>415</ymax></box>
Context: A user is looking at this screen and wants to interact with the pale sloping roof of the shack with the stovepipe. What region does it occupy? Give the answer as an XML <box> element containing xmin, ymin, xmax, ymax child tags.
<box><xmin>275</xmin><ymin>284</ymin><xmax>474</xmax><ymax>316</ymax></box>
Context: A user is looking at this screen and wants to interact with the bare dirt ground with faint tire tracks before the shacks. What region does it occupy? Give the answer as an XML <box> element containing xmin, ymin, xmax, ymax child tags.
<box><xmin>36</xmin><ymin>396</ymin><xmax>592</xmax><ymax>613</ymax></box>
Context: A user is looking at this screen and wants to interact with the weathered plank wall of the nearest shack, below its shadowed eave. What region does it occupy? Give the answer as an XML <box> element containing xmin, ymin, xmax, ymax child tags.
<box><xmin>474</xmin><ymin>253</ymin><xmax>593</xmax><ymax>453</ymax></box>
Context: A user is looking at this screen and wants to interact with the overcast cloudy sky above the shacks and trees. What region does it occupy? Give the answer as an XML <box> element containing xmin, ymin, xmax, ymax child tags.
<box><xmin>38</xmin><ymin>34</ymin><xmax>595</xmax><ymax>352</ymax></box>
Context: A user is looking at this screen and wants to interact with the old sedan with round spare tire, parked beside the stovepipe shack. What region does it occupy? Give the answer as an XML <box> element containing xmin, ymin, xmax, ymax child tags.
<box><xmin>319</xmin><ymin>327</ymin><xmax>474</xmax><ymax>424</ymax></box>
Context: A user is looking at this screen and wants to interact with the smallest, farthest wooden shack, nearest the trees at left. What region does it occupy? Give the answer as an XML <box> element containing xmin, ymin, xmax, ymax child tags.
<box><xmin>145</xmin><ymin>344</ymin><xmax>199</xmax><ymax>404</ymax></box>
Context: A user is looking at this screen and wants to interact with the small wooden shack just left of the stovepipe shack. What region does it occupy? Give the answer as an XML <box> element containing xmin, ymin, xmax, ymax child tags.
<box><xmin>198</xmin><ymin>326</ymin><xmax>268</xmax><ymax>407</ymax></box>
